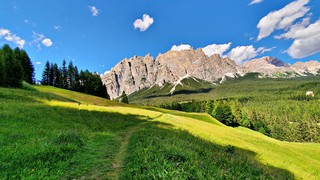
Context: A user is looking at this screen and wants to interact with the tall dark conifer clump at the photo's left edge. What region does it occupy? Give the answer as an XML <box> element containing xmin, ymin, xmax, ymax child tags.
<box><xmin>0</xmin><ymin>44</ymin><xmax>35</xmax><ymax>87</ymax></box>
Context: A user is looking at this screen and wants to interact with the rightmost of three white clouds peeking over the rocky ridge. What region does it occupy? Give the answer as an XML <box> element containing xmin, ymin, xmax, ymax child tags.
<box><xmin>227</xmin><ymin>45</ymin><xmax>275</xmax><ymax>64</ymax></box>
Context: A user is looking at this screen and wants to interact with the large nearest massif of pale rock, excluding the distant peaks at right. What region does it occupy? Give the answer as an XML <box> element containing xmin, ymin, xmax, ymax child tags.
<box><xmin>102</xmin><ymin>49</ymin><xmax>241</xmax><ymax>98</ymax></box>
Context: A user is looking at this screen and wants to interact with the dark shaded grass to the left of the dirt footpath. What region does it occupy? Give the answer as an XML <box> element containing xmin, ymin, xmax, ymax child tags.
<box><xmin>0</xmin><ymin>103</ymin><xmax>147</xmax><ymax>179</ymax></box>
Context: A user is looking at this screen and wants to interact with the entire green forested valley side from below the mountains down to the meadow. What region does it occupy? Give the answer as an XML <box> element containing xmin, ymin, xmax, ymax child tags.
<box><xmin>156</xmin><ymin>76</ymin><xmax>320</xmax><ymax>142</ymax></box>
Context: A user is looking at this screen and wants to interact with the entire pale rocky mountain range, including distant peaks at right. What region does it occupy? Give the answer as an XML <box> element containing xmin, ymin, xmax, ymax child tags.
<box><xmin>102</xmin><ymin>49</ymin><xmax>320</xmax><ymax>98</ymax></box>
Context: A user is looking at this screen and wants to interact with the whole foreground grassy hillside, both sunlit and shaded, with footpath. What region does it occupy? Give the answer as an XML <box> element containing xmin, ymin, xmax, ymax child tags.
<box><xmin>0</xmin><ymin>86</ymin><xmax>320</xmax><ymax>179</ymax></box>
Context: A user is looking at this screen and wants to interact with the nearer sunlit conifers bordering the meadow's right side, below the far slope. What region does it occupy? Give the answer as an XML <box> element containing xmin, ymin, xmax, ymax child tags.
<box><xmin>159</xmin><ymin>98</ymin><xmax>320</xmax><ymax>142</ymax></box>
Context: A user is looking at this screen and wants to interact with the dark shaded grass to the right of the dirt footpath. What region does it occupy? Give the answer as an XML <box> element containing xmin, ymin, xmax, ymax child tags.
<box><xmin>121</xmin><ymin>123</ymin><xmax>294</xmax><ymax>179</ymax></box>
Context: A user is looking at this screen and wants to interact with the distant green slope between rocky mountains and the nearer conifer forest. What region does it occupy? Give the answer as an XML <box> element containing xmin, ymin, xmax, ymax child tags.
<box><xmin>129</xmin><ymin>75</ymin><xmax>320</xmax><ymax>105</ymax></box>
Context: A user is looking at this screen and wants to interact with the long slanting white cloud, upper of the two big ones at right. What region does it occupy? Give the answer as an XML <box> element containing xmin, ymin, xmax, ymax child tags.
<box><xmin>257</xmin><ymin>0</ymin><xmax>310</xmax><ymax>40</ymax></box>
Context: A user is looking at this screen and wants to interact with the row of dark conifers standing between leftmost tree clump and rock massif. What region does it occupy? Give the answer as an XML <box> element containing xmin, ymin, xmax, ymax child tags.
<box><xmin>41</xmin><ymin>60</ymin><xmax>110</xmax><ymax>99</ymax></box>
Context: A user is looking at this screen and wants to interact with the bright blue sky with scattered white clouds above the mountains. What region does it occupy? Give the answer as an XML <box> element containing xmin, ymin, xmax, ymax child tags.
<box><xmin>0</xmin><ymin>0</ymin><xmax>320</xmax><ymax>80</ymax></box>
